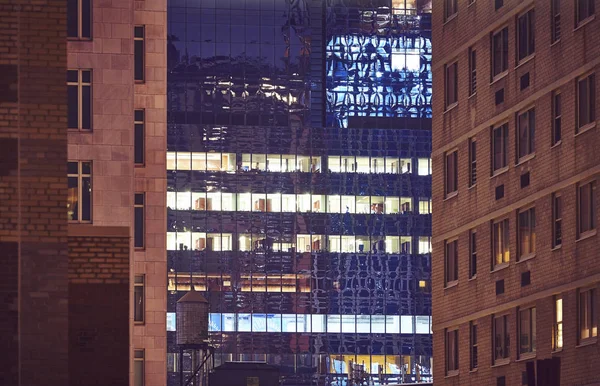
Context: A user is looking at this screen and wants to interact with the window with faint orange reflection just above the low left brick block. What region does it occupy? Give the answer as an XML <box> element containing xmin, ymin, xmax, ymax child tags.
<box><xmin>67</xmin><ymin>161</ymin><xmax>92</xmax><ymax>222</ymax></box>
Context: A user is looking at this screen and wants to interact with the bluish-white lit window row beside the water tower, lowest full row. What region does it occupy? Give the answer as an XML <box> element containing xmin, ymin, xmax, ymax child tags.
<box><xmin>167</xmin><ymin>312</ymin><xmax>431</xmax><ymax>334</ymax></box>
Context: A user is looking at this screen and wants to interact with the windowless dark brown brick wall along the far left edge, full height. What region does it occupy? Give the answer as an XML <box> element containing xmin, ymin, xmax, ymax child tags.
<box><xmin>0</xmin><ymin>0</ymin><xmax>68</xmax><ymax>386</ymax></box>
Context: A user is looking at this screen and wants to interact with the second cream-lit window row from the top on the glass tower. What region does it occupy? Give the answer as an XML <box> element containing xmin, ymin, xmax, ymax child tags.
<box><xmin>167</xmin><ymin>192</ymin><xmax>431</xmax><ymax>214</ymax></box>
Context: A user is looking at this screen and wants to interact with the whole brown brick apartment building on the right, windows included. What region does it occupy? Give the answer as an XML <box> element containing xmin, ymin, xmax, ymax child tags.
<box><xmin>432</xmin><ymin>0</ymin><xmax>600</xmax><ymax>385</ymax></box>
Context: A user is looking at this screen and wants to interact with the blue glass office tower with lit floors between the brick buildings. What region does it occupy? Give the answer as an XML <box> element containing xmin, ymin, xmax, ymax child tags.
<box><xmin>166</xmin><ymin>0</ymin><xmax>432</xmax><ymax>385</ymax></box>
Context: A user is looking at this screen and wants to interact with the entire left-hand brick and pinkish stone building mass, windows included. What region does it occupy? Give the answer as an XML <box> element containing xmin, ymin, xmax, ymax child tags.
<box><xmin>0</xmin><ymin>0</ymin><xmax>167</xmax><ymax>386</ymax></box>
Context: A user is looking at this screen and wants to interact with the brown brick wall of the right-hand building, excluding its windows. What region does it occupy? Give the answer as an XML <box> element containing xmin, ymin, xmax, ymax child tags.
<box><xmin>432</xmin><ymin>0</ymin><xmax>600</xmax><ymax>385</ymax></box>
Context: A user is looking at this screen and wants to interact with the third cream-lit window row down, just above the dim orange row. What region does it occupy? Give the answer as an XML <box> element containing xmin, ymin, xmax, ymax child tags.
<box><xmin>167</xmin><ymin>232</ymin><xmax>431</xmax><ymax>253</ymax></box>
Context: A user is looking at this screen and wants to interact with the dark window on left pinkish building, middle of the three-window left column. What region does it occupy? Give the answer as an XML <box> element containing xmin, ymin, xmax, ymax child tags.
<box><xmin>67</xmin><ymin>70</ymin><xmax>92</xmax><ymax>130</ymax></box>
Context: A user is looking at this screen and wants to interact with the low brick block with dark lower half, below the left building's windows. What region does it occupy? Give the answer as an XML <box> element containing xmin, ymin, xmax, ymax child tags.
<box><xmin>69</xmin><ymin>231</ymin><xmax>129</xmax><ymax>386</ymax></box>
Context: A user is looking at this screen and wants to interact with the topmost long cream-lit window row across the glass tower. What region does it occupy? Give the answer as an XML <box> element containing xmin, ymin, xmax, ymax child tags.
<box><xmin>167</xmin><ymin>152</ymin><xmax>431</xmax><ymax>176</ymax></box>
